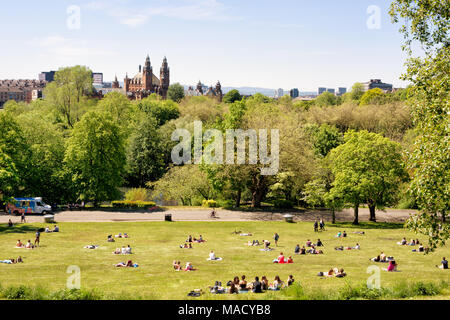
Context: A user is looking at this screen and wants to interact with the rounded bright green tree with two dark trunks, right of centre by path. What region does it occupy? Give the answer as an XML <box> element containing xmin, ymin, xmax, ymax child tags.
<box><xmin>330</xmin><ymin>131</ymin><xmax>407</xmax><ymax>224</ymax></box>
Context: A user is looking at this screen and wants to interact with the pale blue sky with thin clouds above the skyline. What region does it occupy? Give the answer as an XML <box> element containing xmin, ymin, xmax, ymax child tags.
<box><xmin>0</xmin><ymin>0</ymin><xmax>406</xmax><ymax>91</ymax></box>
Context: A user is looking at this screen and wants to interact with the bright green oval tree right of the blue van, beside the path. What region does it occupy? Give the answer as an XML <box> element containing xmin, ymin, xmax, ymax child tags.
<box><xmin>64</xmin><ymin>111</ymin><xmax>125</xmax><ymax>206</ymax></box>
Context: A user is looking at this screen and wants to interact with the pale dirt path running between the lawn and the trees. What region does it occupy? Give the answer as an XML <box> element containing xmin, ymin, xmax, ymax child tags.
<box><xmin>0</xmin><ymin>208</ymin><xmax>414</xmax><ymax>223</ymax></box>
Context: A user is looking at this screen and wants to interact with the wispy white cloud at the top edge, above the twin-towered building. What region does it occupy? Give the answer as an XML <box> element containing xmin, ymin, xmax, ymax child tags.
<box><xmin>85</xmin><ymin>0</ymin><xmax>238</xmax><ymax>27</ymax></box>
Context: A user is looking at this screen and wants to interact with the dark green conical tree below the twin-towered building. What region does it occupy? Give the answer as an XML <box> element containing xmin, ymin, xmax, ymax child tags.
<box><xmin>127</xmin><ymin>116</ymin><xmax>165</xmax><ymax>187</ymax></box>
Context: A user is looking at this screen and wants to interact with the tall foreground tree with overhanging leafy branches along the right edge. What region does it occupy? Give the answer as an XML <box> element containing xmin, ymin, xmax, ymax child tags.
<box><xmin>390</xmin><ymin>0</ymin><xmax>450</xmax><ymax>249</ymax></box>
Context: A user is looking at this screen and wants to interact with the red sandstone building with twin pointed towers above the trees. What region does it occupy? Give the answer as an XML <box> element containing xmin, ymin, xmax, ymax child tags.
<box><xmin>124</xmin><ymin>55</ymin><xmax>170</xmax><ymax>100</ymax></box>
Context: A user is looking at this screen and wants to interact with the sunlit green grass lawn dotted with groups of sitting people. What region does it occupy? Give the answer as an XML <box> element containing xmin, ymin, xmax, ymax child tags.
<box><xmin>0</xmin><ymin>222</ymin><xmax>450</xmax><ymax>300</ymax></box>
